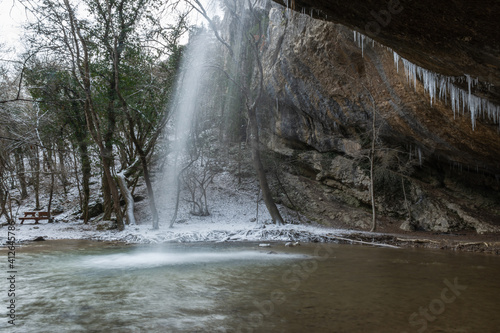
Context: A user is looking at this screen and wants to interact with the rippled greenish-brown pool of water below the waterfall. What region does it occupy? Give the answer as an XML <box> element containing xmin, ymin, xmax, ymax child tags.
<box><xmin>0</xmin><ymin>241</ymin><xmax>500</xmax><ymax>333</ymax></box>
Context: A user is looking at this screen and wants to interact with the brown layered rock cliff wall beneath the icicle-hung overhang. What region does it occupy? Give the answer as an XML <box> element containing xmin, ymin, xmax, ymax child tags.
<box><xmin>260</xmin><ymin>6</ymin><xmax>500</xmax><ymax>233</ymax></box>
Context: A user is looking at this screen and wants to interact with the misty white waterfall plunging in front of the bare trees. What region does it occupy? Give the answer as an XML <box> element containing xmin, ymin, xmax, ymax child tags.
<box><xmin>155</xmin><ymin>1</ymin><xmax>276</xmax><ymax>226</ymax></box>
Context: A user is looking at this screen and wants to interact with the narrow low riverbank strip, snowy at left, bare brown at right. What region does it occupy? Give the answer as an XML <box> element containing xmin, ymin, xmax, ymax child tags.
<box><xmin>0</xmin><ymin>219</ymin><xmax>500</xmax><ymax>255</ymax></box>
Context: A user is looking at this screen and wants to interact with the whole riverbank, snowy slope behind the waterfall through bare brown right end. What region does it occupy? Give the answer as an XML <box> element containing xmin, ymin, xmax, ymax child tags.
<box><xmin>0</xmin><ymin>173</ymin><xmax>500</xmax><ymax>255</ymax></box>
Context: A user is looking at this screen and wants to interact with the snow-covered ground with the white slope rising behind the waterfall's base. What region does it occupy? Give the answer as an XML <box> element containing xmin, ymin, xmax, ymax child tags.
<box><xmin>0</xmin><ymin>172</ymin><xmax>388</xmax><ymax>244</ymax></box>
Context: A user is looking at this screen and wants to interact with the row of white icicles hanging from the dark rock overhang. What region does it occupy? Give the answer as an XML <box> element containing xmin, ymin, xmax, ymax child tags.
<box><xmin>354</xmin><ymin>31</ymin><xmax>500</xmax><ymax>129</ymax></box>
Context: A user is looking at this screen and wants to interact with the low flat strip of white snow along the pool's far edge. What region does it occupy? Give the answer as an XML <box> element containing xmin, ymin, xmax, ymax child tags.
<box><xmin>4</xmin><ymin>219</ymin><xmax>364</xmax><ymax>244</ymax></box>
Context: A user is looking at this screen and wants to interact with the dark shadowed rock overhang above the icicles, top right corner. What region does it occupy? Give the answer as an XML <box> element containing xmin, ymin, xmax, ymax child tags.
<box><xmin>274</xmin><ymin>0</ymin><xmax>500</xmax><ymax>104</ymax></box>
